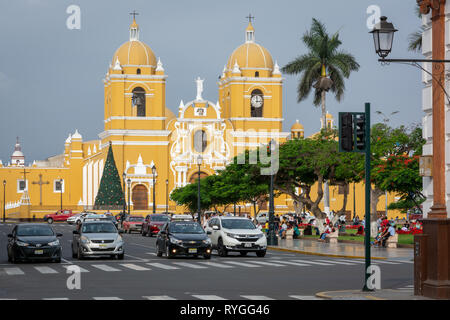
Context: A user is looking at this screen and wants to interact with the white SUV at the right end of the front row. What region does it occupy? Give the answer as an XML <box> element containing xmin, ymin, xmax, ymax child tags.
<box><xmin>206</xmin><ymin>217</ymin><xmax>267</xmax><ymax>257</ymax></box>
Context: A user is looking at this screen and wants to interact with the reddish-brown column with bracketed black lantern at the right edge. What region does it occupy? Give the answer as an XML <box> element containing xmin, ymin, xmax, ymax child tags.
<box><xmin>371</xmin><ymin>11</ymin><xmax>450</xmax><ymax>299</ymax></box>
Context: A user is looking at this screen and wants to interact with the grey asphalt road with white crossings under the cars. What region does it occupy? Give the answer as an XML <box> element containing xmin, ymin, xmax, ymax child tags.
<box><xmin>0</xmin><ymin>223</ymin><xmax>413</xmax><ymax>300</ymax></box>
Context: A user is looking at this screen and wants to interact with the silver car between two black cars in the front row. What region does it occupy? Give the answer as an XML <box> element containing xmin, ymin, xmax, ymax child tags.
<box><xmin>72</xmin><ymin>220</ymin><xmax>125</xmax><ymax>260</ymax></box>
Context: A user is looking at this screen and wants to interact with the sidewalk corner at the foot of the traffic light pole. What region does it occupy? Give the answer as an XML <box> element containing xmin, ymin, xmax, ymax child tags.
<box><xmin>316</xmin><ymin>289</ymin><xmax>433</xmax><ymax>300</ymax></box>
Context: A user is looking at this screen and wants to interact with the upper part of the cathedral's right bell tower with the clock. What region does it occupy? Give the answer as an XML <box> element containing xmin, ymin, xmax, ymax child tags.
<box><xmin>219</xmin><ymin>16</ymin><xmax>283</xmax><ymax>131</ymax></box>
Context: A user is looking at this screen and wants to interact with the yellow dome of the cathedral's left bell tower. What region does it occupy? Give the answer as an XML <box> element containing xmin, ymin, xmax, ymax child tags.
<box><xmin>112</xmin><ymin>40</ymin><xmax>156</xmax><ymax>67</ymax></box>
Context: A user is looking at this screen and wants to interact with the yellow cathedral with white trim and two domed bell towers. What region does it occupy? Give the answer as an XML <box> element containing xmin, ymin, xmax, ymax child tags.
<box><xmin>0</xmin><ymin>19</ymin><xmax>400</xmax><ymax>219</ymax></box>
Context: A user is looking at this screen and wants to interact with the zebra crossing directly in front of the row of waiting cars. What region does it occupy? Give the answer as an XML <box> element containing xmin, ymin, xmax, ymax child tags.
<box><xmin>0</xmin><ymin>257</ymin><xmax>410</xmax><ymax>277</ymax></box>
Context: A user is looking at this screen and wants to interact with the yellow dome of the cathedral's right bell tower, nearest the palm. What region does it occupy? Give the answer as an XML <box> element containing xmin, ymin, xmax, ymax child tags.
<box><xmin>227</xmin><ymin>42</ymin><xmax>273</xmax><ymax>70</ymax></box>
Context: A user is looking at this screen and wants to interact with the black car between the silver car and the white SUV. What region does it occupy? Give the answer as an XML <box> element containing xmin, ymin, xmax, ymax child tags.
<box><xmin>156</xmin><ymin>221</ymin><xmax>212</xmax><ymax>259</ymax></box>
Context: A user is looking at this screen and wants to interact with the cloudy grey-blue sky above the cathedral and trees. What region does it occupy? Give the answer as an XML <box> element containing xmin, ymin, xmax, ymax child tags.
<box><xmin>0</xmin><ymin>0</ymin><xmax>422</xmax><ymax>163</ymax></box>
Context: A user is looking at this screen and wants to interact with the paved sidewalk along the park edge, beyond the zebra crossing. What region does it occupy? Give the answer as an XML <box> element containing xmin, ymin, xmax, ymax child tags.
<box><xmin>268</xmin><ymin>238</ymin><xmax>414</xmax><ymax>261</ymax></box>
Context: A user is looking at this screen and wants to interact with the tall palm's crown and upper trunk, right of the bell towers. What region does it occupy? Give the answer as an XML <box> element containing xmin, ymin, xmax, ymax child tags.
<box><xmin>282</xmin><ymin>18</ymin><xmax>360</xmax><ymax>128</ymax></box>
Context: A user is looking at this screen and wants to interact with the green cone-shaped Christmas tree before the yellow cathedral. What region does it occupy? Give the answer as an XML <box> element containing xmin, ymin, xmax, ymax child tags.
<box><xmin>95</xmin><ymin>145</ymin><xmax>125</xmax><ymax>207</ymax></box>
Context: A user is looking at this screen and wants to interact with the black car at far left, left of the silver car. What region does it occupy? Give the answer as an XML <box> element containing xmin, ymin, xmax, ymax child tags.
<box><xmin>7</xmin><ymin>223</ymin><xmax>62</xmax><ymax>263</ymax></box>
